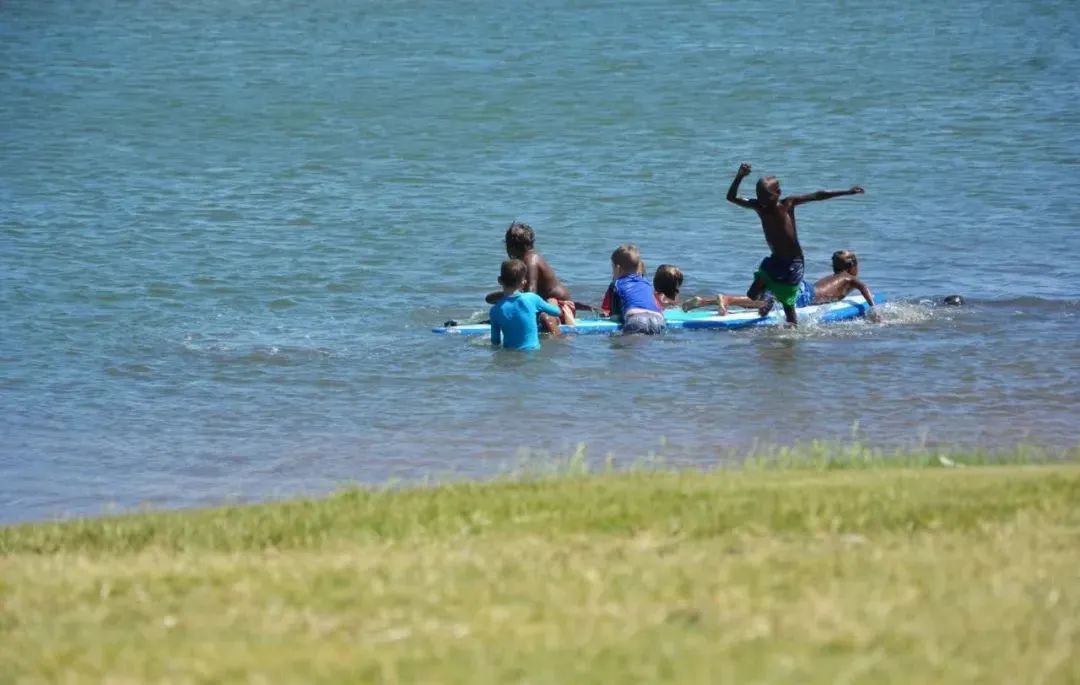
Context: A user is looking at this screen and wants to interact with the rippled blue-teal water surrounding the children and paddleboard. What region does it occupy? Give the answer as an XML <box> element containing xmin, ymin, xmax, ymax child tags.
<box><xmin>0</xmin><ymin>0</ymin><xmax>1080</xmax><ymax>521</ymax></box>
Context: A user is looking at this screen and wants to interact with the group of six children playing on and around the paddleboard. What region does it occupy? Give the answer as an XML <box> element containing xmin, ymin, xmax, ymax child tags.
<box><xmin>487</xmin><ymin>163</ymin><xmax>874</xmax><ymax>350</ymax></box>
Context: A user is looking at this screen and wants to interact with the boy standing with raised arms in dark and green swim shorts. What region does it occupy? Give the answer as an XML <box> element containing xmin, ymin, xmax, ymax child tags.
<box><xmin>728</xmin><ymin>162</ymin><xmax>863</xmax><ymax>326</ymax></box>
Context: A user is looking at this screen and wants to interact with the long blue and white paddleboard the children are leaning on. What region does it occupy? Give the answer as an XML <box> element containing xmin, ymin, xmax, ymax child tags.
<box><xmin>432</xmin><ymin>293</ymin><xmax>886</xmax><ymax>335</ymax></box>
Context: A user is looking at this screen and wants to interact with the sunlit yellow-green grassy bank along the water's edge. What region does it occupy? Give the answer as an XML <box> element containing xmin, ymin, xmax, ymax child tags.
<box><xmin>0</xmin><ymin>457</ymin><xmax>1080</xmax><ymax>684</ymax></box>
